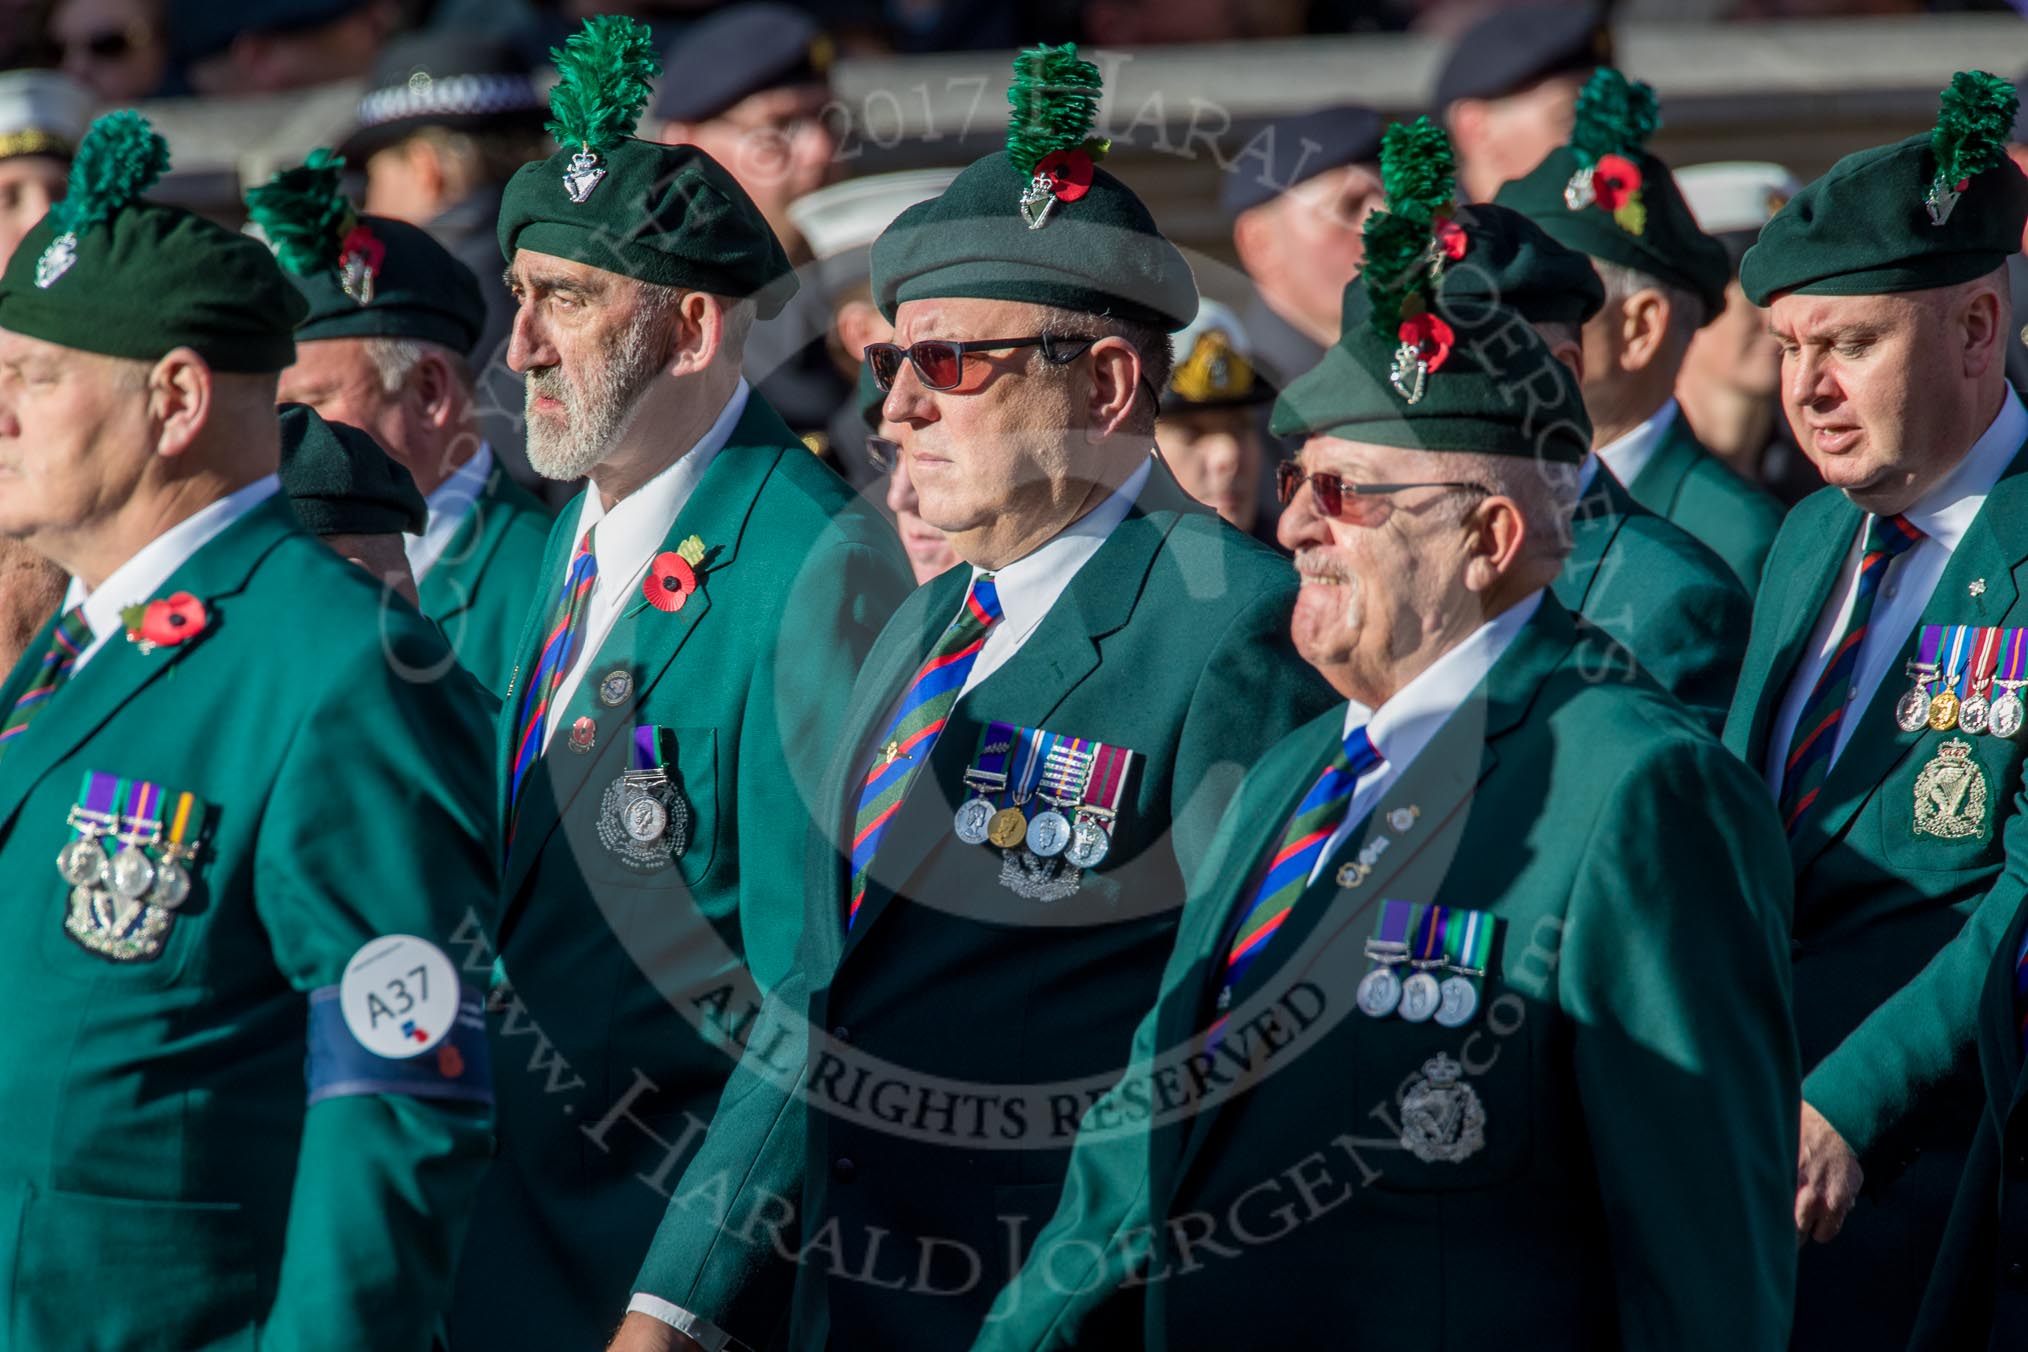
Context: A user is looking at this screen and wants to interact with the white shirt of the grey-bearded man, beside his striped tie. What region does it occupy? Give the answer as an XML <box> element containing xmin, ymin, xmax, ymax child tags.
<box><xmin>541</xmin><ymin>379</ymin><xmax>748</xmax><ymax>748</ymax></box>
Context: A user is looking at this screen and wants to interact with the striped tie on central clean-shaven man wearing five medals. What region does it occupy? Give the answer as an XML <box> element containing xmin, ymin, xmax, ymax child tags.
<box><xmin>846</xmin><ymin>574</ymin><xmax>1000</xmax><ymax>930</ymax></box>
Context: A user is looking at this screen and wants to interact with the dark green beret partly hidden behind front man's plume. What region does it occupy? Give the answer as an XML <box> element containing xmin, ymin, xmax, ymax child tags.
<box><xmin>1436</xmin><ymin>203</ymin><xmax>1606</xmax><ymax>324</ymax></box>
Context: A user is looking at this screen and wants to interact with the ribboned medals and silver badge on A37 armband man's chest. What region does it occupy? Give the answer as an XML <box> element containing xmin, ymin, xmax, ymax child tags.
<box><xmin>57</xmin><ymin>770</ymin><xmax>205</xmax><ymax>963</ymax></box>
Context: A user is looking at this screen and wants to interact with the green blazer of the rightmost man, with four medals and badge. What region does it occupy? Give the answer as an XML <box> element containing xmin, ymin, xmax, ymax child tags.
<box><xmin>1726</xmin><ymin>441</ymin><xmax>2028</xmax><ymax>1340</ymax></box>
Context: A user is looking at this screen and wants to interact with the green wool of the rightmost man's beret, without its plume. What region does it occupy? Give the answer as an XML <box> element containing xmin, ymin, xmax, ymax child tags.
<box><xmin>1740</xmin><ymin>132</ymin><xmax>2028</xmax><ymax>306</ymax></box>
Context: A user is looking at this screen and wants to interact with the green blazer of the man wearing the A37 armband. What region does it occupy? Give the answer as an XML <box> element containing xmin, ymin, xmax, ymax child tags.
<box><xmin>0</xmin><ymin>497</ymin><xmax>497</xmax><ymax>1352</ymax></box>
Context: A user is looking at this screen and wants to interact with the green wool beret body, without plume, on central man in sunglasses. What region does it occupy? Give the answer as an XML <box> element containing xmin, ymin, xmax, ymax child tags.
<box><xmin>872</xmin><ymin>150</ymin><xmax>1197</xmax><ymax>332</ymax></box>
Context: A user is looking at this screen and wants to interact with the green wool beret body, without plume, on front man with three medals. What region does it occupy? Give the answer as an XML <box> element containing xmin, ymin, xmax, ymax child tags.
<box><xmin>1272</xmin><ymin>283</ymin><xmax>1592</xmax><ymax>464</ymax></box>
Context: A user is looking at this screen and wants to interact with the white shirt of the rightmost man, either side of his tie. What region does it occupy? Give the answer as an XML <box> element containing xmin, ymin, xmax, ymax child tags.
<box><xmin>1764</xmin><ymin>389</ymin><xmax>2028</xmax><ymax>799</ymax></box>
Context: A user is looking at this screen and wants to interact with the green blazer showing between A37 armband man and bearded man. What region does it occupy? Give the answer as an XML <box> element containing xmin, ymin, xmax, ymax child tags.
<box><xmin>416</xmin><ymin>460</ymin><xmax>550</xmax><ymax>697</ymax></box>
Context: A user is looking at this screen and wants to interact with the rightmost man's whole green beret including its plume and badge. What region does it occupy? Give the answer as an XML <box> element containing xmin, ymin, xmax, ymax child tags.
<box><xmin>1740</xmin><ymin>71</ymin><xmax>2028</xmax><ymax>306</ymax></box>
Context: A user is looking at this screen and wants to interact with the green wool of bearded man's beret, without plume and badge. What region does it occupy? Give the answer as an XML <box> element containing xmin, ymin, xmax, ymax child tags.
<box><xmin>499</xmin><ymin>138</ymin><xmax>797</xmax><ymax>318</ymax></box>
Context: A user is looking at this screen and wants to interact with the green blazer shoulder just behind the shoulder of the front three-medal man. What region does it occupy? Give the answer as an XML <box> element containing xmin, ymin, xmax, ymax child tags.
<box><xmin>1553</xmin><ymin>464</ymin><xmax>1752</xmax><ymax>732</ymax></box>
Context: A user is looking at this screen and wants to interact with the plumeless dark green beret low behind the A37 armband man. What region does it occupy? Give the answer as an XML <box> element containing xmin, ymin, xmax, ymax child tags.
<box><xmin>280</xmin><ymin>403</ymin><xmax>430</xmax><ymax>535</ymax></box>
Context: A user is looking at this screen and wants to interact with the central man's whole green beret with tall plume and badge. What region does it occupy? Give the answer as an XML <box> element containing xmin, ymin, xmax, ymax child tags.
<box><xmin>872</xmin><ymin>43</ymin><xmax>1197</xmax><ymax>332</ymax></box>
